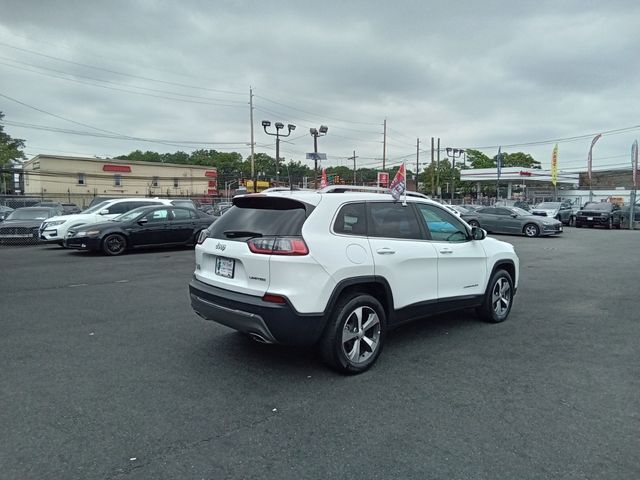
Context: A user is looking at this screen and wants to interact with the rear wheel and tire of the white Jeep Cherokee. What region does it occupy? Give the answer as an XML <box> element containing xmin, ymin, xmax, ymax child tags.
<box><xmin>320</xmin><ymin>293</ymin><xmax>387</xmax><ymax>375</ymax></box>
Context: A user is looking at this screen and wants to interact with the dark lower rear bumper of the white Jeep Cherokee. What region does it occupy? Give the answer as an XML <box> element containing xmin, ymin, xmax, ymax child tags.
<box><xmin>189</xmin><ymin>278</ymin><xmax>325</xmax><ymax>345</ymax></box>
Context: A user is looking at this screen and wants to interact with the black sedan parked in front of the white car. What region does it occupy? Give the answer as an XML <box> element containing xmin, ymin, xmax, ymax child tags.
<box><xmin>64</xmin><ymin>205</ymin><xmax>215</xmax><ymax>255</ymax></box>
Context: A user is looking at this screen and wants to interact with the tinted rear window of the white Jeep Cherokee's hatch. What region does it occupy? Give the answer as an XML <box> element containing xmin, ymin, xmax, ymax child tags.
<box><xmin>209</xmin><ymin>196</ymin><xmax>313</xmax><ymax>240</ymax></box>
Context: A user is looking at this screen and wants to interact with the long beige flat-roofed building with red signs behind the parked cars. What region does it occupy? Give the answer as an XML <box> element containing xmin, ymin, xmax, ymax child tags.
<box><xmin>23</xmin><ymin>155</ymin><xmax>218</xmax><ymax>206</ymax></box>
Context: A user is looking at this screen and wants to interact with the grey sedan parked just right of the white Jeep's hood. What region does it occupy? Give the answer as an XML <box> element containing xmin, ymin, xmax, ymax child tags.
<box><xmin>462</xmin><ymin>207</ymin><xmax>562</xmax><ymax>237</ymax></box>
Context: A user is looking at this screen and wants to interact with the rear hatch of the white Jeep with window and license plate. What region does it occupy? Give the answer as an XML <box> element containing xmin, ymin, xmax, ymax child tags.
<box><xmin>195</xmin><ymin>195</ymin><xmax>314</xmax><ymax>296</ymax></box>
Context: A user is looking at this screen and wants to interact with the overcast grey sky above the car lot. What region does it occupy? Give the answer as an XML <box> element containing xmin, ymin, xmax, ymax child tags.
<box><xmin>0</xmin><ymin>0</ymin><xmax>640</xmax><ymax>171</ymax></box>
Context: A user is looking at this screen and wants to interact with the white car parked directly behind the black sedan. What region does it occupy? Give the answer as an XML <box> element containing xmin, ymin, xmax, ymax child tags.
<box><xmin>40</xmin><ymin>197</ymin><xmax>171</xmax><ymax>246</ymax></box>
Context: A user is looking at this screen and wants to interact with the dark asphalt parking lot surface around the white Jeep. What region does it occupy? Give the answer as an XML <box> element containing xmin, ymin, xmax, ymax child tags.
<box><xmin>0</xmin><ymin>228</ymin><xmax>640</xmax><ymax>480</ymax></box>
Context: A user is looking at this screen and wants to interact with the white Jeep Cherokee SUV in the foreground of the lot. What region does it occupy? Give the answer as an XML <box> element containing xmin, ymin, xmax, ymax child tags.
<box><xmin>189</xmin><ymin>187</ymin><xmax>519</xmax><ymax>373</ymax></box>
